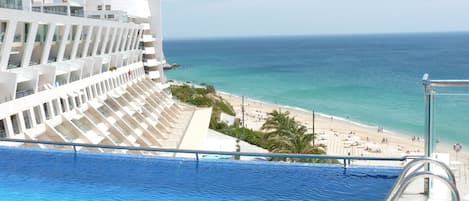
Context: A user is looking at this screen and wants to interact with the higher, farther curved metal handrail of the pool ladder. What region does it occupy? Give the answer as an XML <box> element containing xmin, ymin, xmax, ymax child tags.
<box><xmin>385</xmin><ymin>157</ymin><xmax>456</xmax><ymax>201</ymax></box>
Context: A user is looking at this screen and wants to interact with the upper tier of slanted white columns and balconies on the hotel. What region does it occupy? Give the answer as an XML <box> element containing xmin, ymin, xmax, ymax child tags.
<box><xmin>0</xmin><ymin>9</ymin><xmax>143</xmax><ymax>97</ymax></box>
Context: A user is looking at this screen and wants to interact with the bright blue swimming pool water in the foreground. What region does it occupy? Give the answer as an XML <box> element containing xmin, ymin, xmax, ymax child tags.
<box><xmin>0</xmin><ymin>147</ymin><xmax>401</xmax><ymax>201</ymax></box>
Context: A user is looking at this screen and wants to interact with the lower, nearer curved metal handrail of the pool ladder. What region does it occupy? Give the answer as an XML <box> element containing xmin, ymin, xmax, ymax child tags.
<box><xmin>389</xmin><ymin>171</ymin><xmax>461</xmax><ymax>201</ymax></box>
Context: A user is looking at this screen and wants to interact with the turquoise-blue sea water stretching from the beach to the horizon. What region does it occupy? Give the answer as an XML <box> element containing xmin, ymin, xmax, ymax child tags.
<box><xmin>164</xmin><ymin>33</ymin><xmax>469</xmax><ymax>144</ymax></box>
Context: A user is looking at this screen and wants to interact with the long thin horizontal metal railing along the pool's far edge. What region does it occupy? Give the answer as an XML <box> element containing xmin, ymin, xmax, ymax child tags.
<box><xmin>0</xmin><ymin>138</ymin><xmax>410</xmax><ymax>168</ymax></box>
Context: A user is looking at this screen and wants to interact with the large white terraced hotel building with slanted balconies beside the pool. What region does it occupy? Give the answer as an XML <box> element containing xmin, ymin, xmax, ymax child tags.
<box><xmin>0</xmin><ymin>0</ymin><xmax>211</xmax><ymax>151</ymax></box>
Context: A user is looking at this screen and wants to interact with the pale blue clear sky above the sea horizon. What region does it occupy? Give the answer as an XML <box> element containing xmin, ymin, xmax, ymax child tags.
<box><xmin>162</xmin><ymin>0</ymin><xmax>469</xmax><ymax>38</ymax></box>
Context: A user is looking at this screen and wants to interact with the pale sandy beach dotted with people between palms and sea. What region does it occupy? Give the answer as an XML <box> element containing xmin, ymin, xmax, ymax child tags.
<box><xmin>218</xmin><ymin>92</ymin><xmax>469</xmax><ymax>165</ymax></box>
